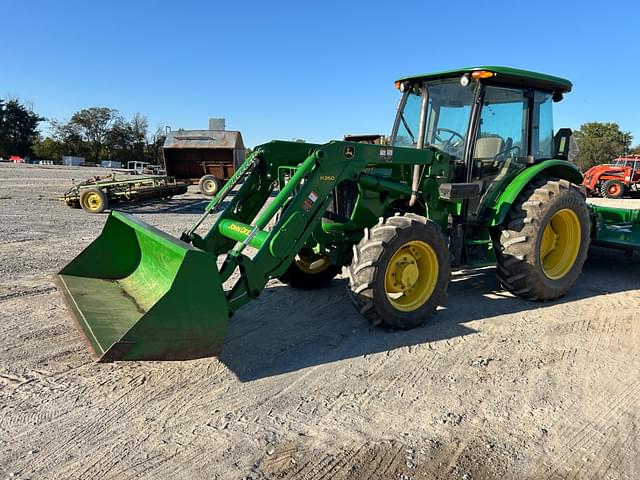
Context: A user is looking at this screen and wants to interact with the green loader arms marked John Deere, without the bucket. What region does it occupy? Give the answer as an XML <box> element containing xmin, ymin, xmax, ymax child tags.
<box><xmin>183</xmin><ymin>141</ymin><xmax>438</xmax><ymax>313</ymax></box>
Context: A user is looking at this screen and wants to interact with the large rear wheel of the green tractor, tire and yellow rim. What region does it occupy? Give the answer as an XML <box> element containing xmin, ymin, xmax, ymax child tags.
<box><xmin>494</xmin><ymin>179</ymin><xmax>591</xmax><ymax>300</ymax></box>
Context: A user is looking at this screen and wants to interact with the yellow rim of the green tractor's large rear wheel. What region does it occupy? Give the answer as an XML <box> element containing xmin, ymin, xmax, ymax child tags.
<box><xmin>540</xmin><ymin>208</ymin><xmax>582</xmax><ymax>280</ymax></box>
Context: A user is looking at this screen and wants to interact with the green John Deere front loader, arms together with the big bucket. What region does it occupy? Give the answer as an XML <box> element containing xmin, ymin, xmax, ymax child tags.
<box><xmin>57</xmin><ymin>141</ymin><xmax>442</xmax><ymax>361</ymax></box>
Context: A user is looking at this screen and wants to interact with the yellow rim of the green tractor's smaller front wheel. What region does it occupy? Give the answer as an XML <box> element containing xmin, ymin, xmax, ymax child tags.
<box><xmin>384</xmin><ymin>240</ymin><xmax>440</xmax><ymax>312</ymax></box>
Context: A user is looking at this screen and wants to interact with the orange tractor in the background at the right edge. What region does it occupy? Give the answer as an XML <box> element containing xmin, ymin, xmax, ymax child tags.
<box><xmin>582</xmin><ymin>155</ymin><xmax>640</xmax><ymax>198</ymax></box>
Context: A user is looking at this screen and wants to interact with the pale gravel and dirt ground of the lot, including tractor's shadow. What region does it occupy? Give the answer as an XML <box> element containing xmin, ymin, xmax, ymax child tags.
<box><xmin>0</xmin><ymin>164</ymin><xmax>640</xmax><ymax>480</ymax></box>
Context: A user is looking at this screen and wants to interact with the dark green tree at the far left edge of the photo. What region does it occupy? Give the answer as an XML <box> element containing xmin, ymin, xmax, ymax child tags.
<box><xmin>0</xmin><ymin>99</ymin><xmax>44</xmax><ymax>157</ymax></box>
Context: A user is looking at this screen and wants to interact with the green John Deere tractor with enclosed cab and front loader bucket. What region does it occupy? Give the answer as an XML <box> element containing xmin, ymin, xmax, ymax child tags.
<box><xmin>58</xmin><ymin>67</ymin><xmax>640</xmax><ymax>361</ymax></box>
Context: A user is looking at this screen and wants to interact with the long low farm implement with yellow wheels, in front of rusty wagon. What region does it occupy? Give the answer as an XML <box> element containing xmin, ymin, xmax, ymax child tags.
<box><xmin>61</xmin><ymin>171</ymin><xmax>187</xmax><ymax>213</ymax></box>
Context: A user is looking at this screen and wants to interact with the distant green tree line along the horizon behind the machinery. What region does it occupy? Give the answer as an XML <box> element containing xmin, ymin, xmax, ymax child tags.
<box><xmin>0</xmin><ymin>99</ymin><xmax>640</xmax><ymax>171</ymax></box>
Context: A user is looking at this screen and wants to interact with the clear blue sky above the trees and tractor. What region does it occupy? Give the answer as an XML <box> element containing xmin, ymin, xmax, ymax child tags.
<box><xmin>5</xmin><ymin>0</ymin><xmax>640</xmax><ymax>146</ymax></box>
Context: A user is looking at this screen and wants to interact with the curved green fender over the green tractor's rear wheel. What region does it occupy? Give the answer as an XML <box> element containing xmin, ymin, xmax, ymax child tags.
<box><xmin>491</xmin><ymin>159</ymin><xmax>582</xmax><ymax>226</ymax></box>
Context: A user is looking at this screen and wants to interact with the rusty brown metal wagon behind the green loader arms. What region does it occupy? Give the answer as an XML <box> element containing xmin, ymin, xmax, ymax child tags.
<box><xmin>163</xmin><ymin>130</ymin><xmax>246</xmax><ymax>187</ymax></box>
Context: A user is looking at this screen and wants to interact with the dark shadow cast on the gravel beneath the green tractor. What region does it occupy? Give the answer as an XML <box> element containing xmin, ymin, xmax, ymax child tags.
<box><xmin>219</xmin><ymin>249</ymin><xmax>640</xmax><ymax>382</ymax></box>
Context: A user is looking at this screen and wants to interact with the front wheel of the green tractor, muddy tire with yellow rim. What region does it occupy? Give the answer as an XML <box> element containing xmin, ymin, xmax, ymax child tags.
<box><xmin>348</xmin><ymin>213</ymin><xmax>450</xmax><ymax>329</ymax></box>
